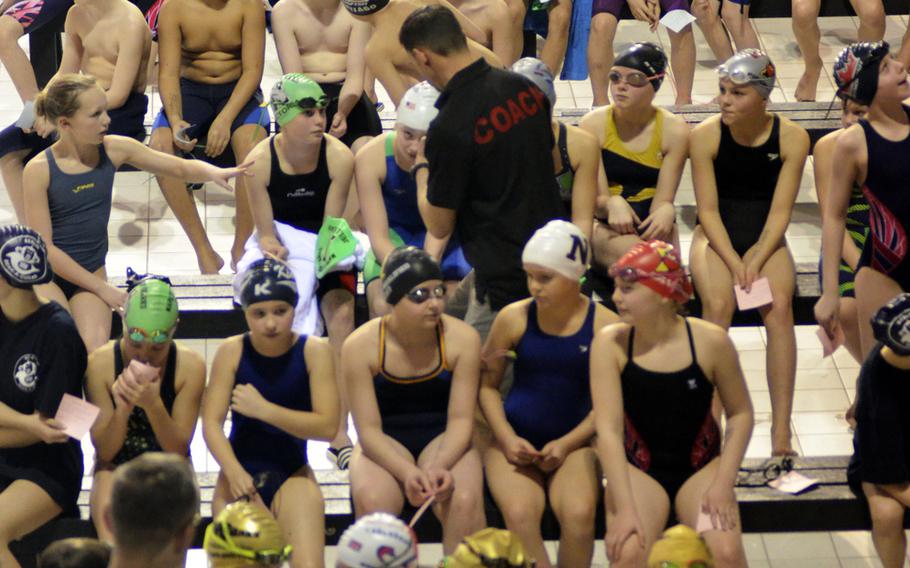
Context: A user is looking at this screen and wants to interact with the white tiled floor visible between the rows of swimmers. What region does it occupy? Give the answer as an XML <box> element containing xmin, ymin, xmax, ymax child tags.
<box><xmin>0</xmin><ymin>16</ymin><xmax>910</xmax><ymax>568</ymax></box>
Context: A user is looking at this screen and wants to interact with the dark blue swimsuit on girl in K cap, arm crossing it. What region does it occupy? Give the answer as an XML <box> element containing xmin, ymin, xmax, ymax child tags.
<box><xmin>229</xmin><ymin>333</ymin><xmax>313</xmax><ymax>506</ymax></box>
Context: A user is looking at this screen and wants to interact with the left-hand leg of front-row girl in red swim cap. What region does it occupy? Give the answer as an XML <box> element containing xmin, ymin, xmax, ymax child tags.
<box><xmin>604</xmin><ymin>464</ymin><xmax>670</xmax><ymax>568</ymax></box>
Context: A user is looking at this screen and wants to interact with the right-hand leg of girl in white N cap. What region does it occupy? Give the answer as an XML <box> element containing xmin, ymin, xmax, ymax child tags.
<box><xmin>549</xmin><ymin>446</ymin><xmax>600</xmax><ymax>568</ymax></box>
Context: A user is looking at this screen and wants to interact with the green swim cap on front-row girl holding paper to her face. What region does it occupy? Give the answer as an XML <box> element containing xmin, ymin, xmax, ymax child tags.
<box><xmin>124</xmin><ymin>278</ymin><xmax>180</xmax><ymax>343</ymax></box>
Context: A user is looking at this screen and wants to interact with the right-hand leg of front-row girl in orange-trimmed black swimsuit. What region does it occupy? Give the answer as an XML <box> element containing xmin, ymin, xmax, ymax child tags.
<box><xmin>418</xmin><ymin>435</ymin><xmax>487</xmax><ymax>554</ymax></box>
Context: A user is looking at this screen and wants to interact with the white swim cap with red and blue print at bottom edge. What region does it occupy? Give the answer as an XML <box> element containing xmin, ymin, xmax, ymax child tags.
<box><xmin>337</xmin><ymin>513</ymin><xmax>417</xmax><ymax>568</ymax></box>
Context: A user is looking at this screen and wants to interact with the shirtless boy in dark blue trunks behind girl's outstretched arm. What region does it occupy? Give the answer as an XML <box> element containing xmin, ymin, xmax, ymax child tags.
<box><xmin>151</xmin><ymin>0</ymin><xmax>270</xmax><ymax>274</ymax></box>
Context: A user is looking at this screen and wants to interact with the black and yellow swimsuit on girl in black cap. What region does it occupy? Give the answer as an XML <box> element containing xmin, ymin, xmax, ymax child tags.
<box><xmin>600</xmin><ymin>106</ymin><xmax>667</xmax><ymax>221</ymax></box>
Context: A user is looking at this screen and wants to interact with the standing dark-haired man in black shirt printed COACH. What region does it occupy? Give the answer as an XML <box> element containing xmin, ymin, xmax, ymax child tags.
<box><xmin>399</xmin><ymin>6</ymin><xmax>564</xmax><ymax>335</ymax></box>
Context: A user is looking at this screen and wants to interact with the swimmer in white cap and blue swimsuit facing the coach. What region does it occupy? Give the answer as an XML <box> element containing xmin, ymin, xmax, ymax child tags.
<box><xmin>354</xmin><ymin>82</ymin><xmax>471</xmax><ymax>317</ymax></box>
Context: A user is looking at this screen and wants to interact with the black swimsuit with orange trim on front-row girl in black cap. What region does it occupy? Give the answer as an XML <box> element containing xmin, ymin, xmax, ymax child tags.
<box><xmin>373</xmin><ymin>318</ymin><xmax>452</xmax><ymax>459</ymax></box>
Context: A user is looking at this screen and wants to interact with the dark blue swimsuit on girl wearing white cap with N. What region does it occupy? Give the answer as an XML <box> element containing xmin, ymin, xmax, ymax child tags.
<box><xmin>504</xmin><ymin>301</ymin><xmax>596</xmax><ymax>450</ymax></box>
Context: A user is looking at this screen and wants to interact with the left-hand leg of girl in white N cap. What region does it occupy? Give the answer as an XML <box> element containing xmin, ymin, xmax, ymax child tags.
<box><xmin>483</xmin><ymin>443</ymin><xmax>548</xmax><ymax>568</ymax></box>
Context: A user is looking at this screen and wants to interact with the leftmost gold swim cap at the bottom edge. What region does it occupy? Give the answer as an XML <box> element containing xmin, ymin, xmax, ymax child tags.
<box><xmin>202</xmin><ymin>501</ymin><xmax>291</xmax><ymax>568</ymax></box>
